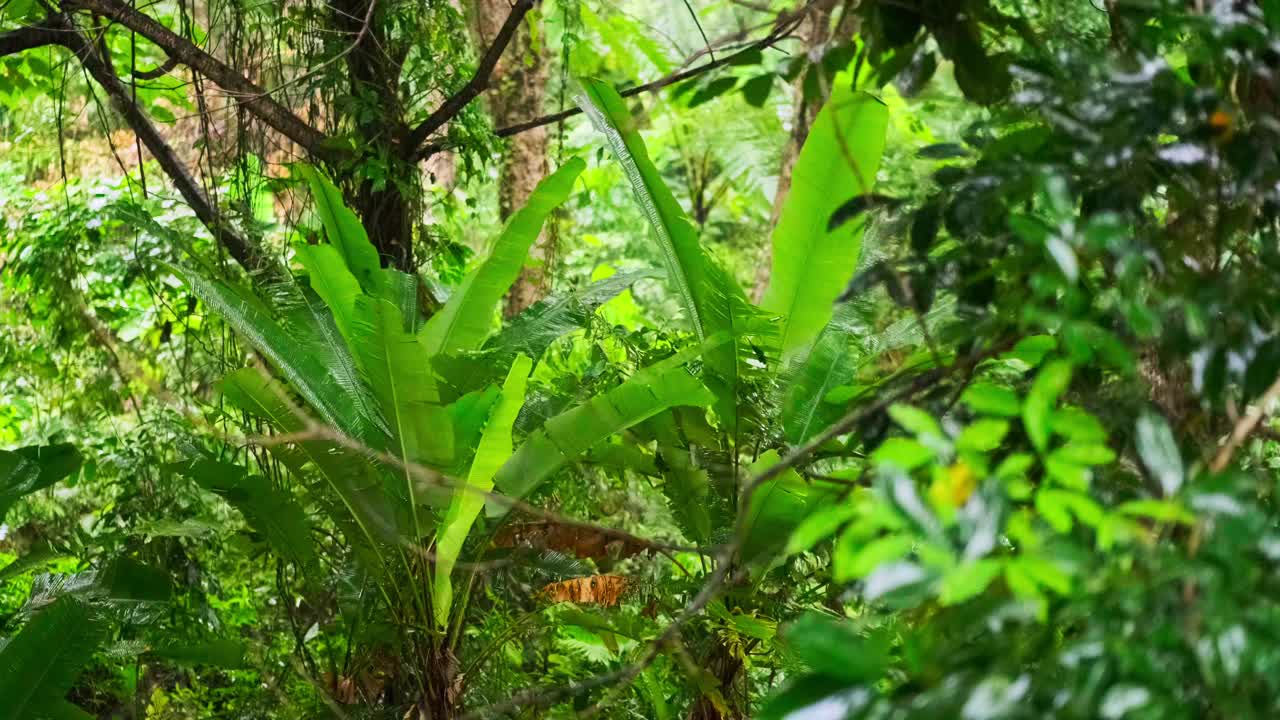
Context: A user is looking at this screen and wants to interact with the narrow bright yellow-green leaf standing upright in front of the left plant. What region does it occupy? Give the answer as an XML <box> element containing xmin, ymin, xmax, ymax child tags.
<box><xmin>431</xmin><ymin>355</ymin><xmax>534</xmax><ymax>626</ymax></box>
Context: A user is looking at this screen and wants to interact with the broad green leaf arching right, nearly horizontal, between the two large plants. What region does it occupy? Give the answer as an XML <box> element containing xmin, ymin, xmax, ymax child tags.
<box><xmin>489</xmin><ymin>347</ymin><xmax>714</xmax><ymax>507</ymax></box>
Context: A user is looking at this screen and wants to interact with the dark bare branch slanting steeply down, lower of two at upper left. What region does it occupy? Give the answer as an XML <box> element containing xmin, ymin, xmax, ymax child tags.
<box><xmin>54</xmin><ymin>18</ymin><xmax>275</xmax><ymax>274</ymax></box>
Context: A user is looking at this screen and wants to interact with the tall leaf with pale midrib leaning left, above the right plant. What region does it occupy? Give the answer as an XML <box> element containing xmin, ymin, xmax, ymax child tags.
<box><xmin>575</xmin><ymin>79</ymin><xmax>749</xmax><ymax>436</ymax></box>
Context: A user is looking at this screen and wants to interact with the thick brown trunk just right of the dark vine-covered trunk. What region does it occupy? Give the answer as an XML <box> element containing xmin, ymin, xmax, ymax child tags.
<box><xmin>471</xmin><ymin>0</ymin><xmax>556</xmax><ymax>316</ymax></box>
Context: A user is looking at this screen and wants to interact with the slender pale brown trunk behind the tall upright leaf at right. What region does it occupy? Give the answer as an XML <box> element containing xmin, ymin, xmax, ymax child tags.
<box><xmin>751</xmin><ymin>0</ymin><xmax>852</xmax><ymax>302</ymax></box>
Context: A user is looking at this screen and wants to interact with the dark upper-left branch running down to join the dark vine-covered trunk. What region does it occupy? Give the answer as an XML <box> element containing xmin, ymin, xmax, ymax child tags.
<box><xmin>63</xmin><ymin>0</ymin><xmax>326</xmax><ymax>155</ymax></box>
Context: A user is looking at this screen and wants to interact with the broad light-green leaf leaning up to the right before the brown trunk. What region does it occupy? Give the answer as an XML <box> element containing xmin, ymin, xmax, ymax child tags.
<box><xmin>422</xmin><ymin>158</ymin><xmax>586</xmax><ymax>355</ymax></box>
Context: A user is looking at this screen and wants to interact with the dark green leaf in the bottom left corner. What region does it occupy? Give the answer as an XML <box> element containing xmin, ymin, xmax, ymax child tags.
<box><xmin>0</xmin><ymin>597</ymin><xmax>106</xmax><ymax>720</ymax></box>
